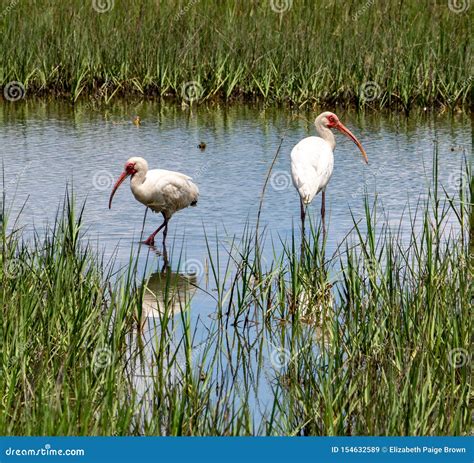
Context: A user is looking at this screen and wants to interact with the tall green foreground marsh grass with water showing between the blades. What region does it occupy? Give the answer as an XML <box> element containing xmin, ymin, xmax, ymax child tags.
<box><xmin>0</xmin><ymin>151</ymin><xmax>474</xmax><ymax>435</ymax></box>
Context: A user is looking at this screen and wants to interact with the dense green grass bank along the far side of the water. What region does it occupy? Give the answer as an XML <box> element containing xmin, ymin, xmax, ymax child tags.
<box><xmin>0</xmin><ymin>0</ymin><xmax>472</xmax><ymax>111</ymax></box>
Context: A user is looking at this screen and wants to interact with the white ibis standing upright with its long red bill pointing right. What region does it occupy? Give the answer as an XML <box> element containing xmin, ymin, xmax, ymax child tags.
<box><xmin>291</xmin><ymin>111</ymin><xmax>369</xmax><ymax>236</ymax></box>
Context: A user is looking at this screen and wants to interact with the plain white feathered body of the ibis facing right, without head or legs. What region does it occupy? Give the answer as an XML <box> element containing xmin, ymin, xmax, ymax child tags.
<box><xmin>291</xmin><ymin>137</ymin><xmax>334</xmax><ymax>204</ymax></box>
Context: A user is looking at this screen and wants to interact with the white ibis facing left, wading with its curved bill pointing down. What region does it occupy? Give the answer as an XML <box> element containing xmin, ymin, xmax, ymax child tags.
<box><xmin>109</xmin><ymin>157</ymin><xmax>199</xmax><ymax>250</ymax></box>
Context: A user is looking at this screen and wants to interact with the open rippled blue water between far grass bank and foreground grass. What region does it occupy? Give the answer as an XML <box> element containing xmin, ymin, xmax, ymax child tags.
<box><xmin>0</xmin><ymin>101</ymin><xmax>472</xmax><ymax>424</ymax></box>
